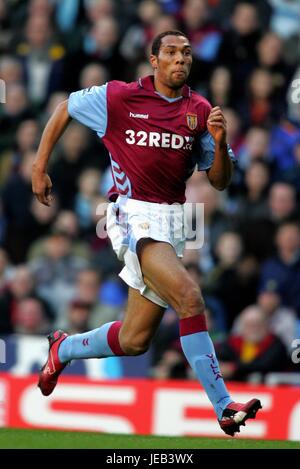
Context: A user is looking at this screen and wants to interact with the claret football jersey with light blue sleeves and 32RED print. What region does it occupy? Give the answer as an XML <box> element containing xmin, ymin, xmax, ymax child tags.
<box><xmin>68</xmin><ymin>76</ymin><xmax>234</xmax><ymax>204</ymax></box>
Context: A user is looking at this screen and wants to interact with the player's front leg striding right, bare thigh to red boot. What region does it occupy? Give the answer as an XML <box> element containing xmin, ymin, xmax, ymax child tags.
<box><xmin>139</xmin><ymin>240</ymin><xmax>260</xmax><ymax>435</ymax></box>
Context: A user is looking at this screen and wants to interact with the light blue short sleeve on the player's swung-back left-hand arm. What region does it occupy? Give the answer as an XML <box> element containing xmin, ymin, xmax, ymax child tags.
<box><xmin>68</xmin><ymin>84</ymin><xmax>107</xmax><ymax>137</ymax></box>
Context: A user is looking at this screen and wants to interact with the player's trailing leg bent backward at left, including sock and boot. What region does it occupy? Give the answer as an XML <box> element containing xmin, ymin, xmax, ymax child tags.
<box><xmin>38</xmin><ymin>288</ymin><xmax>164</xmax><ymax>395</ymax></box>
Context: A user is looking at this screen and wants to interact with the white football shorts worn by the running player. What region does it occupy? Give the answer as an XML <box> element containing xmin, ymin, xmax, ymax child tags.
<box><xmin>106</xmin><ymin>196</ymin><xmax>185</xmax><ymax>308</ymax></box>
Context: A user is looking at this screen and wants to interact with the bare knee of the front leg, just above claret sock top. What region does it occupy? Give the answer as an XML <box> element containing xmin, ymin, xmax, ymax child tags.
<box><xmin>177</xmin><ymin>279</ymin><xmax>205</xmax><ymax>318</ymax></box>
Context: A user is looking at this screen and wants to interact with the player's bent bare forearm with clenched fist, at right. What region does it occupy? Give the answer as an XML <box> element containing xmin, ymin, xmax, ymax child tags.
<box><xmin>207</xmin><ymin>106</ymin><xmax>233</xmax><ymax>191</ymax></box>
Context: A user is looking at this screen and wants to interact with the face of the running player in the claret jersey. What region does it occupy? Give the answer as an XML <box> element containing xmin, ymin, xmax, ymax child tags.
<box><xmin>151</xmin><ymin>36</ymin><xmax>193</xmax><ymax>90</ymax></box>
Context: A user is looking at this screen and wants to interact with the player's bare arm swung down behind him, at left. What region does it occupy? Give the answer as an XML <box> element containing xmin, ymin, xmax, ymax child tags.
<box><xmin>32</xmin><ymin>100</ymin><xmax>71</xmax><ymax>206</ymax></box>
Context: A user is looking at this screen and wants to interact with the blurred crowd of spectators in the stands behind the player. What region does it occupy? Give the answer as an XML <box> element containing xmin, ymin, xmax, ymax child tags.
<box><xmin>0</xmin><ymin>0</ymin><xmax>300</xmax><ymax>380</ymax></box>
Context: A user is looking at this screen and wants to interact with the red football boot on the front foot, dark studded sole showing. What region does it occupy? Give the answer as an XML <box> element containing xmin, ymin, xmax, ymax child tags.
<box><xmin>219</xmin><ymin>399</ymin><xmax>262</xmax><ymax>436</ymax></box>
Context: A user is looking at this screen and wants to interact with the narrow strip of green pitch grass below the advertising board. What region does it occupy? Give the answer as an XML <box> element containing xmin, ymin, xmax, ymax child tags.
<box><xmin>0</xmin><ymin>428</ymin><xmax>300</xmax><ymax>449</ymax></box>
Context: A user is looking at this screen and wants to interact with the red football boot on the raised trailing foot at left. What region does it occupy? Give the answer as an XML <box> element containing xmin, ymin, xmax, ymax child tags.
<box><xmin>38</xmin><ymin>330</ymin><xmax>68</xmax><ymax>396</ymax></box>
